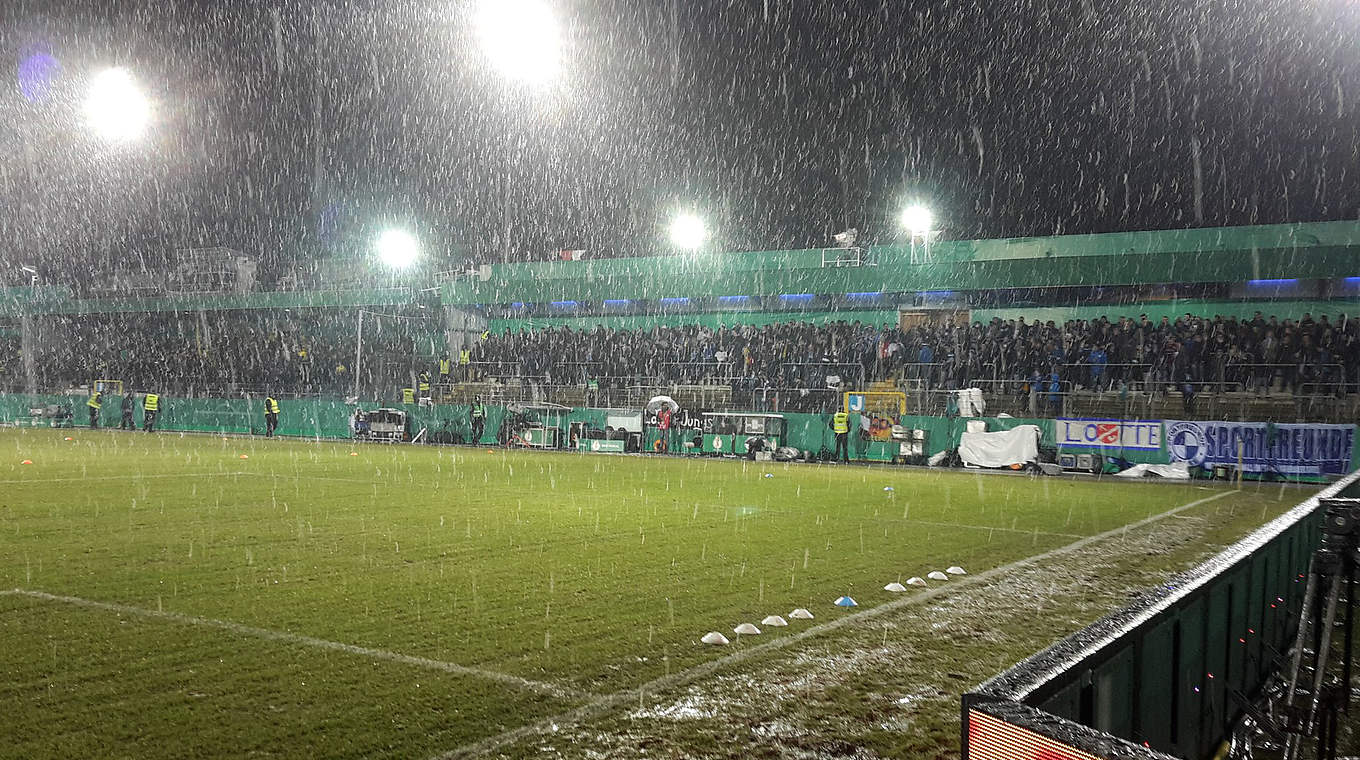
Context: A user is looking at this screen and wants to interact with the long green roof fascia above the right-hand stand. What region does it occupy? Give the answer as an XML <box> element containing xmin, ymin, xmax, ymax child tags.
<box><xmin>441</xmin><ymin>222</ymin><xmax>1360</xmax><ymax>305</ymax></box>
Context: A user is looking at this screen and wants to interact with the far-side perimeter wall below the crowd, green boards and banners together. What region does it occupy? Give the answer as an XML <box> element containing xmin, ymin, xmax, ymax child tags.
<box><xmin>0</xmin><ymin>386</ymin><xmax>1360</xmax><ymax>480</ymax></box>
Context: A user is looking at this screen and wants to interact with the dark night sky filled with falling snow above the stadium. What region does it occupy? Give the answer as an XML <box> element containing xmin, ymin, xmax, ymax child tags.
<box><xmin>0</xmin><ymin>0</ymin><xmax>1360</xmax><ymax>279</ymax></box>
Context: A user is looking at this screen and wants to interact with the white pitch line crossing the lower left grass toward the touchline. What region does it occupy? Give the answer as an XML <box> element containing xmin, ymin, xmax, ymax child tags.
<box><xmin>4</xmin><ymin>589</ymin><xmax>590</xmax><ymax>699</ymax></box>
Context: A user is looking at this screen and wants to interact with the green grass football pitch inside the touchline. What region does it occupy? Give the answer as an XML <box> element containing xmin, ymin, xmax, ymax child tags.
<box><xmin>0</xmin><ymin>430</ymin><xmax>1303</xmax><ymax>759</ymax></box>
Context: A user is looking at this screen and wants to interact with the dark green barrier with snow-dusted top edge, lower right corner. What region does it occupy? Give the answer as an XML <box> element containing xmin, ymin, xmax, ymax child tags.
<box><xmin>960</xmin><ymin>472</ymin><xmax>1360</xmax><ymax>760</ymax></box>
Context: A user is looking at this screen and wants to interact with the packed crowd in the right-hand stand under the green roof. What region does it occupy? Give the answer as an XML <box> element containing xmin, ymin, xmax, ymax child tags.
<box><xmin>473</xmin><ymin>313</ymin><xmax>1360</xmax><ymax>393</ymax></box>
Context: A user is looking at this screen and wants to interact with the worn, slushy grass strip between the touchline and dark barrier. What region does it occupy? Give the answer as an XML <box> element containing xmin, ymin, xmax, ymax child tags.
<box><xmin>498</xmin><ymin>488</ymin><xmax>1306</xmax><ymax>759</ymax></box>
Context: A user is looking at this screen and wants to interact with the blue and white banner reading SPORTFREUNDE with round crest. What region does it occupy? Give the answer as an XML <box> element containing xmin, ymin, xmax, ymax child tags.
<box><xmin>1166</xmin><ymin>420</ymin><xmax>1356</xmax><ymax>474</ymax></box>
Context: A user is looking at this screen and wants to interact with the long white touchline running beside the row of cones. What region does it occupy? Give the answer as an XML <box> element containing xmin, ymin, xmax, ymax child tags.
<box><xmin>430</xmin><ymin>491</ymin><xmax>1236</xmax><ymax>760</ymax></box>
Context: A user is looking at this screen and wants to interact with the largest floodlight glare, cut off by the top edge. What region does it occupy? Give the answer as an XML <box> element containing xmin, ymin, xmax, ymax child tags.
<box><xmin>476</xmin><ymin>0</ymin><xmax>562</xmax><ymax>86</ymax></box>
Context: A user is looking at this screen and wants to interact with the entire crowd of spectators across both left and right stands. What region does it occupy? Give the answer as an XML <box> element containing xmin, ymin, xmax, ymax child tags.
<box><xmin>0</xmin><ymin>309</ymin><xmax>1360</xmax><ymax>405</ymax></box>
